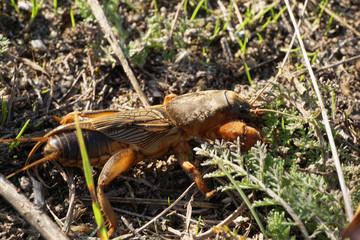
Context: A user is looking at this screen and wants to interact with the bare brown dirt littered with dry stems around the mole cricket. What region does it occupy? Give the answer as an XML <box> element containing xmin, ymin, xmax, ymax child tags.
<box><xmin>0</xmin><ymin>0</ymin><xmax>360</xmax><ymax>239</ymax></box>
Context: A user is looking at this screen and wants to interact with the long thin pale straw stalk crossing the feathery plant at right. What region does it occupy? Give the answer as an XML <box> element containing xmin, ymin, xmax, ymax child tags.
<box><xmin>285</xmin><ymin>0</ymin><xmax>354</xmax><ymax>221</ymax></box>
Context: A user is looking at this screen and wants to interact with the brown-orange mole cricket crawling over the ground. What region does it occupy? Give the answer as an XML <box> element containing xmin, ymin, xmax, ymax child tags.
<box><xmin>0</xmin><ymin>90</ymin><xmax>263</xmax><ymax>235</ymax></box>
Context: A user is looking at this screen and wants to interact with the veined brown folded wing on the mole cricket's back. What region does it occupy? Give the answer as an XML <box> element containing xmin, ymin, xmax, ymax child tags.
<box><xmin>89</xmin><ymin>106</ymin><xmax>174</xmax><ymax>148</ymax></box>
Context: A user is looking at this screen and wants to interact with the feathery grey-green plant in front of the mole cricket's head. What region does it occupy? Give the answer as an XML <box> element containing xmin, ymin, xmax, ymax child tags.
<box><xmin>194</xmin><ymin>93</ymin><xmax>350</xmax><ymax>239</ymax></box>
